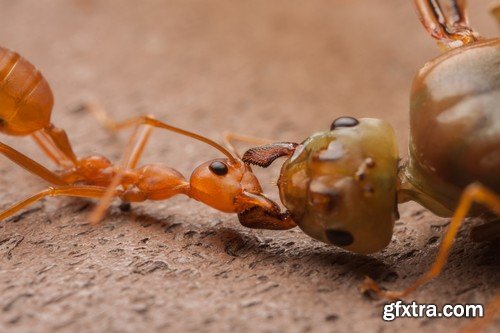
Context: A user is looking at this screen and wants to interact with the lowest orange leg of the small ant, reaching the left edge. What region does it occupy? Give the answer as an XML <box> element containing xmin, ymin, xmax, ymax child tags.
<box><xmin>0</xmin><ymin>185</ymin><xmax>116</xmax><ymax>221</ymax></box>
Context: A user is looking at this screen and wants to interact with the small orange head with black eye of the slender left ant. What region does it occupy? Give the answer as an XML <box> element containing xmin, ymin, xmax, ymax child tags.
<box><xmin>189</xmin><ymin>158</ymin><xmax>262</xmax><ymax>213</ymax></box>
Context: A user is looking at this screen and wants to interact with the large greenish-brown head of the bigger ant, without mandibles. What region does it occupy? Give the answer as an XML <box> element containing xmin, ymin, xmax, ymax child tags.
<box><xmin>279</xmin><ymin>117</ymin><xmax>398</xmax><ymax>253</ymax></box>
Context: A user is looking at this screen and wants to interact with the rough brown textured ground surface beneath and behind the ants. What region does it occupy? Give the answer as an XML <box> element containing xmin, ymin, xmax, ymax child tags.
<box><xmin>0</xmin><ymin>0</ymin><xmax>500</xmax><ymax>332</ymax></box>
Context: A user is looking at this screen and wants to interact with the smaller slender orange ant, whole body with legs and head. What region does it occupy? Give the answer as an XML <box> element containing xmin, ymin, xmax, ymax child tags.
<box><xmin>0</xmin><ymin>48</ymin><xmax>295</xmax><ymax>229</ymax></box>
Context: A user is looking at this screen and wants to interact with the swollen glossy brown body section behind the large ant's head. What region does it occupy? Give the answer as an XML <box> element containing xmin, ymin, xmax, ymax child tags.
<box><xmin>410</xmin><ymin>39</ymin><xmax>500</xmax><ymax>205</ymax></box>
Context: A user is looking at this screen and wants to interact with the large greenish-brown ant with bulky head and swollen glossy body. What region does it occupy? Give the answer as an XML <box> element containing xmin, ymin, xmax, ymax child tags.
<box><xmin>238</xmin><ymin>0</ymin><xmax>500</xmax><ymax>298</ymax></box>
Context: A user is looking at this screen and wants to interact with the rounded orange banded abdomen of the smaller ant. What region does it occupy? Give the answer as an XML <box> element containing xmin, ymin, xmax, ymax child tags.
<box><xmin>0</xmin><ymin>47</ymin><xmax>54</xmax><ymax>135</ymax></box>
